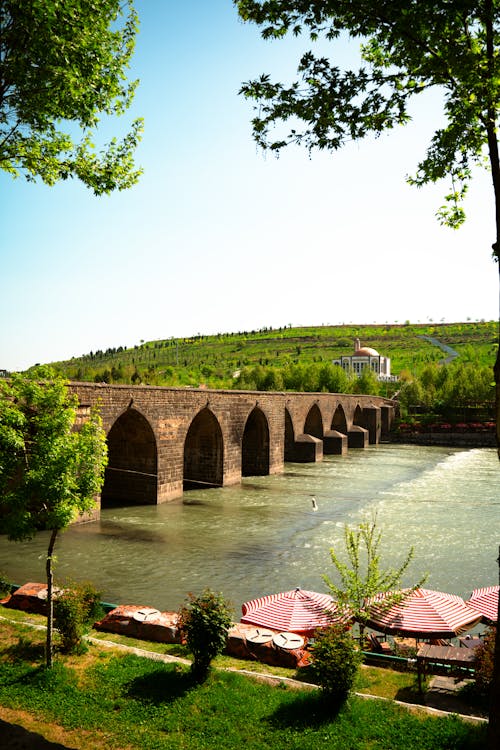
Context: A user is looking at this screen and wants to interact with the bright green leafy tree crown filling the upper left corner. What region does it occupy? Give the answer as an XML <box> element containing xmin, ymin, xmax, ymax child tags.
<box><xmin>0</xmin><ymin>0</ymin><xmax>142</xmax><ymax>195</ymax></box>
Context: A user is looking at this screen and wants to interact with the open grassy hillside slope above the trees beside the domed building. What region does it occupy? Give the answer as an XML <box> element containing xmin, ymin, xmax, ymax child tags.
<box><xmin>45</xmin><ymin>321</ymin><xmax>498</xmax><ymax>388</ymax></box>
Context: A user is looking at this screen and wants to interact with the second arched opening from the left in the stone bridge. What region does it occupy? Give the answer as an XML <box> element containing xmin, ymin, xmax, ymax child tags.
<box><xmin>184</xmin><ymin>407</ymin><xmax>223</xmax><ymax>490</ymax></box>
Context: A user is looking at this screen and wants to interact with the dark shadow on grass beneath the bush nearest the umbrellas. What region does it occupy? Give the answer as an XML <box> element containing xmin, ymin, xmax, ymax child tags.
<box><xmin>268</xmin><ymin>691</ymin><xmax>345</xmax><ymax>729</ymax></box>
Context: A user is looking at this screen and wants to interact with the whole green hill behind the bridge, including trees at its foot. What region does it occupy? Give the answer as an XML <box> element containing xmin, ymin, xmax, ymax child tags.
<box><xmin>19</xmin><ymin>321</ymin><xmax>498</xmax><ymax>420</ymax></box>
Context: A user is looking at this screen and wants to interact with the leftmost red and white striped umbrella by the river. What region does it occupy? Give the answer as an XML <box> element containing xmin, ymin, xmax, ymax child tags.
<box><xmin>241</xmin><ymin>588</ymin><xmax>348</xmax><ymax>636</ymax></box>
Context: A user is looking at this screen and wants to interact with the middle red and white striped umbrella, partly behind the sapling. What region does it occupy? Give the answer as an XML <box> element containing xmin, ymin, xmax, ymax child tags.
<box><xmin>367</xmin><ymin>589</ymin><xmax>481</xmax><ymax>638</ymax></box>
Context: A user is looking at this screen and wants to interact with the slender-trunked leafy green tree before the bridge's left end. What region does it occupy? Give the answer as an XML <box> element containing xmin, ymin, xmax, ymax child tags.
<box><xmin>0</xmin><ymin>367</ymin><xmax>107</xmax><ymax>667</ymax></box>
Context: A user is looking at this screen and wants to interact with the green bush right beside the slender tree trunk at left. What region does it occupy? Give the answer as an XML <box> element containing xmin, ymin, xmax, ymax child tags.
<box><xmin>54</xmin><ymin>582</ymin><xmax>103</xmax><ymax>653</ymax></box>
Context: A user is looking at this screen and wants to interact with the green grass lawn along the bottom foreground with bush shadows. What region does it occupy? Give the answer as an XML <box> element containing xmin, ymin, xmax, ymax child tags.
<box><xmin>0</xmin><ymin>612</ymin><xmax>486</xmax><ymax>750</ymax></box>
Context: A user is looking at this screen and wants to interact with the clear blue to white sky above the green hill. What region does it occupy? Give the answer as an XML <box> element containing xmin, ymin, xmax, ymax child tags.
<box><xmin>0</xmin><ymin>0</ymin><xmax>498</xmax><ymax>370</ymax></box>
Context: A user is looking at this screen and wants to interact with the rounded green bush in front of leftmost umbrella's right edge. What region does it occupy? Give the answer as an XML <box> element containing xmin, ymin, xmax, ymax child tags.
<box><xmin>311</xmin><ymin>625</ymin><xmax>361</xmax><ymax>706</ymax></box>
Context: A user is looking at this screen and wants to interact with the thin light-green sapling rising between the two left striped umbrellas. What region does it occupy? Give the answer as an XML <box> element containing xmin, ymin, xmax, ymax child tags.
<box><xmin>323</xmin><ymin>515</ymin><xmax>426</xmax><ymax>644</ymax></box>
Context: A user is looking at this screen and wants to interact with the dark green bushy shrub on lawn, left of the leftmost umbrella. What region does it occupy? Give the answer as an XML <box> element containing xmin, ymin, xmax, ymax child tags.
<box><xmin>179</xmin><ymin>589</ymin><xmax>232</xmax><ymax>682</ymax></box>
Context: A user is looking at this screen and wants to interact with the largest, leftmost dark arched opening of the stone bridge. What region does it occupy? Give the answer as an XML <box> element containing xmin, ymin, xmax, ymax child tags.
<box><xmin>101</xmin><ymin>409</ymin><xmax>158</xmax><ymax>507</ymax></box>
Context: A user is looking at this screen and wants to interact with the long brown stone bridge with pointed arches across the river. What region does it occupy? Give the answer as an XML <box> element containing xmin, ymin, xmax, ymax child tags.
<box><xmin>69</xmin><ymin>383</ymin><xmax>395</xmax><ymax>518</ymax></box>
